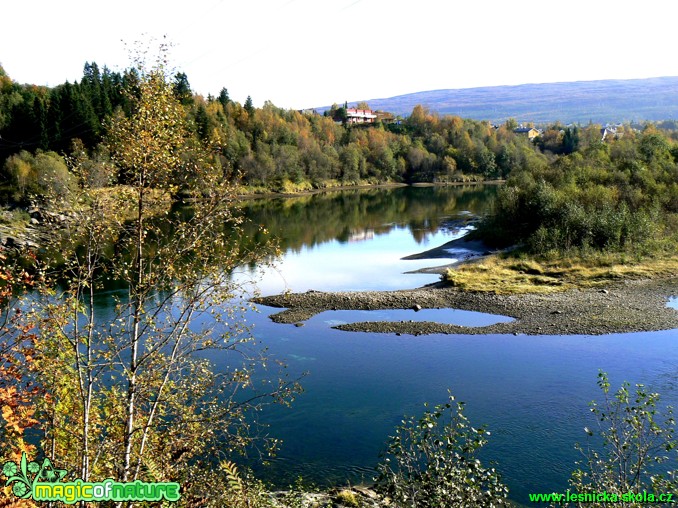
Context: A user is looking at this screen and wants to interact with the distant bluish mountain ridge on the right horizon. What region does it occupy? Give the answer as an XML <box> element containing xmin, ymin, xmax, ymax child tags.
<box><xmin>342</xmin><ymin>77</ymin><xmax>678</xmax><ymax>124</ymax></box>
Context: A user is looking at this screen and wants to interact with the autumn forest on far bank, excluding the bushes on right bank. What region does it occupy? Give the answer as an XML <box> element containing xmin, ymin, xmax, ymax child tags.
<box><xmin>0</xmin><ymin>63</ymin><xmax>540</xmax><ymax>203</ymax></box>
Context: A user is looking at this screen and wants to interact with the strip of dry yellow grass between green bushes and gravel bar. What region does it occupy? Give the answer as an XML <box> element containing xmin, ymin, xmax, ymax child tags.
<box><xmin>445</xmin><ymin>254</ymin><xmax>678</xmax><ymax>294</ymax></box>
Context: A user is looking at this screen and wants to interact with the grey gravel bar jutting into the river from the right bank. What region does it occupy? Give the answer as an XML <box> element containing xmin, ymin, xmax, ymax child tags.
<box><xmin>254</xmin><ymin>277</ymin><xmax>678</xmax><ymax>335</ymax></box>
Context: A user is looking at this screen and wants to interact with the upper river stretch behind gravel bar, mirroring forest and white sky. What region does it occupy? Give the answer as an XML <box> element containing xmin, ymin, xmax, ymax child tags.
<box><xmin>231</xmin><ymin>186</ymin><xmax>496</xmax><ymax>294</ymax></box>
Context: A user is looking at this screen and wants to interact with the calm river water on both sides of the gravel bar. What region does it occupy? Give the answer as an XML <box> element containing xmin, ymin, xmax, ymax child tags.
<box><xmin>226</xmin><ymin>187</ymin><xmax>678</xmax><ymax>504</ymax></box>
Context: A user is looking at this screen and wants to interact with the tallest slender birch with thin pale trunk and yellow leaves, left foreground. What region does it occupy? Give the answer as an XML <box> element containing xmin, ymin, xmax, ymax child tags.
<box><xmin>107</xmin><ymin>39</ymin><xmax>292</xmax><ymax>480</ymax></box>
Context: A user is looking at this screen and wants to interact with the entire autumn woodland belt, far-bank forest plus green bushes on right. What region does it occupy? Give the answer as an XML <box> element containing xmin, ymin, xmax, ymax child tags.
<box><xmin>0</xmin><ymin>62</ymin><xmax>678</xmax><ymax>262</ymax></box>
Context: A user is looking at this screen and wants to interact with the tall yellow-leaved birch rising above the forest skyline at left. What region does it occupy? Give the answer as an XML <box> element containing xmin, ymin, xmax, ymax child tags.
<box><xmin>106</xmin><ymin>41</ymin><xmax>291</xmax><ymax>481</ymax></box>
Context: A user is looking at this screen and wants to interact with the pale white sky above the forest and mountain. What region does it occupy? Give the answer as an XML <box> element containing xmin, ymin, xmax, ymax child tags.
<box><xmin>0</xmin><ymin>0</ymin><xmax>678</xmax><ymax>109</ymax></box>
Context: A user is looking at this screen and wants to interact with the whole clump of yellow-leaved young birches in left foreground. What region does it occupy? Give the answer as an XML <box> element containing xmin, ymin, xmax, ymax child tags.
<box><xmin>9</xmin><ymin>40</ymin><xmax>296</xmax><ymax>504</ymax></box>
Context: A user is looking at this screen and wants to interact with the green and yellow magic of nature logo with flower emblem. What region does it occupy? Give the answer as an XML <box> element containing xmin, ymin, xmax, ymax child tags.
<box><xmin>2</xmin><ymin>452</ymin><xmax>181</xmax><ymax>504</ymax></box>
